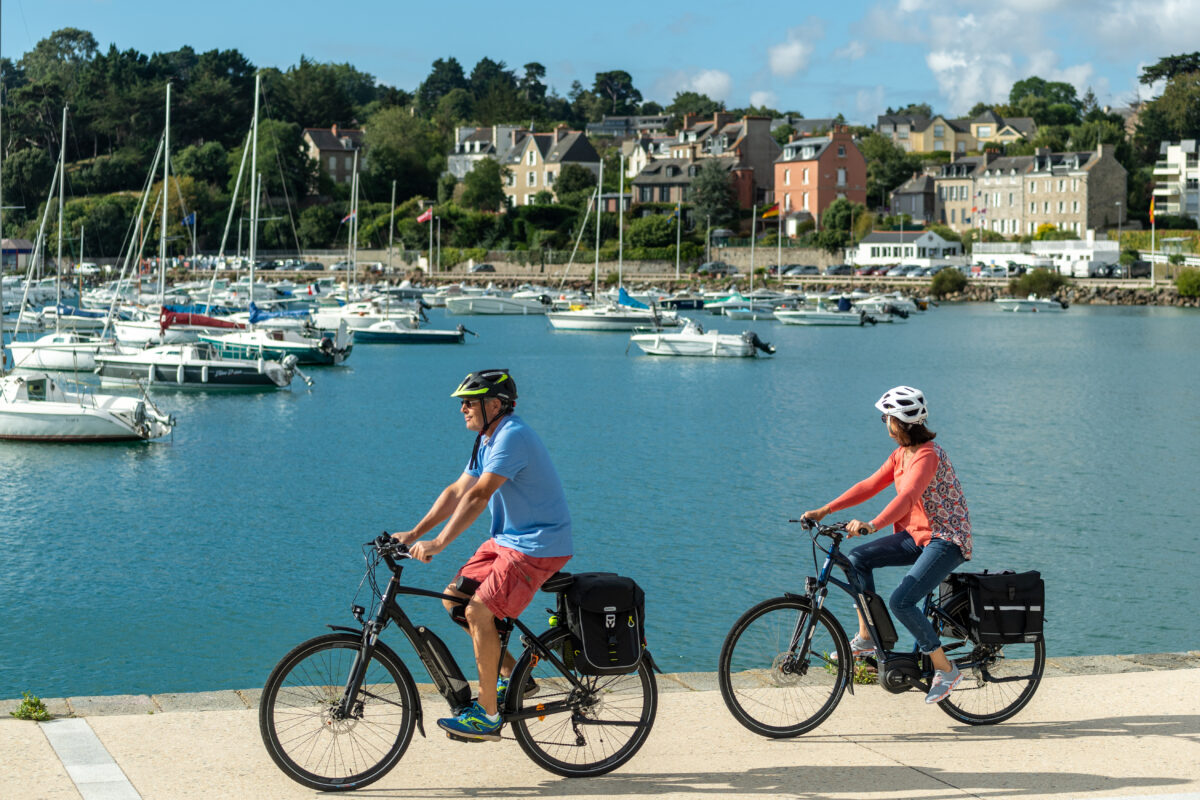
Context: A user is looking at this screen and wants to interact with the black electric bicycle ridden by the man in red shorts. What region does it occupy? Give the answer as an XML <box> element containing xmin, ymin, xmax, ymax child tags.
<box><xmin>258</xmin><ymin>534</ymin><xmax>658</xmax><ymax>792</ymax></box>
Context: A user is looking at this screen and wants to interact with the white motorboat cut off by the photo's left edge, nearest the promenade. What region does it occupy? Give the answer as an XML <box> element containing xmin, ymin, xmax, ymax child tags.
<box><xmin>0</xmin><ymin>373</ymin><xmax>175</xmax><ymax>441</ymax></box>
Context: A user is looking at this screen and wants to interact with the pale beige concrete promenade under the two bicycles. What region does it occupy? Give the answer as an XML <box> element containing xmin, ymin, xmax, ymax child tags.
<box><xmin>0</xmin><ymin>651</ymin><xmax>1200</xmax><ymax>800</ymax></box>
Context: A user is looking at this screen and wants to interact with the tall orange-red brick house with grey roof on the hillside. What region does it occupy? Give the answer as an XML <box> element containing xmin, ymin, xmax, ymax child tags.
<box><xmin>774</xmin><ymin>125</ymin><xmax>866</xmax><ymax>221</ymax></box>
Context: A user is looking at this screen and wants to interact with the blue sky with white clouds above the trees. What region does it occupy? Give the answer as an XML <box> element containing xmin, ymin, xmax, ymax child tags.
<box><xmin>0</xmin><ymin>0</ymin><xmax>1200</xmax><ymax>122</ymax></box>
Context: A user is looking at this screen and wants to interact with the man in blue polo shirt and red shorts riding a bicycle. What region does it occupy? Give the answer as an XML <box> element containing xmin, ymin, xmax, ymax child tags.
<box><xmin>392</xmin><ymin>369</ymin><xmax>574</xmax><ymax>741</ymax></box>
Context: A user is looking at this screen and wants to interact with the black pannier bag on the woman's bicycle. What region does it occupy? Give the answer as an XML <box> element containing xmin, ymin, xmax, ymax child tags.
<box><xmin>962</xmin><ymin>570</ymin><xmax>1046</xmax><ymax>644</ymax></box>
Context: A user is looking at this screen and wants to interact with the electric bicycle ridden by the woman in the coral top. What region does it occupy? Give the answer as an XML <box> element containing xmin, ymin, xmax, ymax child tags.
<box><xmin>718</xmin><ymin>519</ymin><xmax>1045</xmax><ymax>739</ymax></box>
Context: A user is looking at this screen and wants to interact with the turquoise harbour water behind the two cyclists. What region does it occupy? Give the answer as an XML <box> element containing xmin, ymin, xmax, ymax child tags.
<box><xmin>0</xmin><ymin>305</ymin><xmax>1200</xmax><ymax>697</ymax></box>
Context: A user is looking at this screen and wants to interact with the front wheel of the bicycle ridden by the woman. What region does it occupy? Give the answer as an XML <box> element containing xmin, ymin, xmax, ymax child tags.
<box><xmin>716</xmin><ymin>597</ymin><xmax>852</xmax><ymax>739</ymax></box>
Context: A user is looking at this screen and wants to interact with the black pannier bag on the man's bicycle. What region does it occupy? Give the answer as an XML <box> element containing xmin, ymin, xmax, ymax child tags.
<box><xmin>564</xmin><ymin>572</ymin><xmax>646</xmax><ymax>675</ymax></box>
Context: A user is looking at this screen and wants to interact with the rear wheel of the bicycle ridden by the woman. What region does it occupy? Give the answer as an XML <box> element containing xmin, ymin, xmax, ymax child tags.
<box><xmin>930</xmin><ymin>595</ymin><xmax>1046</xmax><ymax>724</ymax></box>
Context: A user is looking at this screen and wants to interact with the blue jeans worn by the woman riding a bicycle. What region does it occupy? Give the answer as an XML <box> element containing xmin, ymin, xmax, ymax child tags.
<box><xmin>846</xmin><ymin>531</ymin><xmax>965</xmax><ymax>655</ymax></box>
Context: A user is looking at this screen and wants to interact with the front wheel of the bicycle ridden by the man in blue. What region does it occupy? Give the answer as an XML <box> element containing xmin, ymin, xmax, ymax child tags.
<box><xmin>258</xmin><ymin>633</ymin><xmax>419</xmax><ymax>792</ymax></box>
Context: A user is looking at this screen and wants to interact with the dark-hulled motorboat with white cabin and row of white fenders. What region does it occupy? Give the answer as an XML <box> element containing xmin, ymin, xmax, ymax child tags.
<box><xmin>96</xmin><ymin>342</ymin><xmax>312</xmax><ymax>390</ymax></box>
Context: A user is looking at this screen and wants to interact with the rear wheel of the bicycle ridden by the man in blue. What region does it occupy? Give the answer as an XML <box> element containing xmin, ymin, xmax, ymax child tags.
<box><xmin>509</xmin><ymin>628</ymin><xmax>659</xmax><ymax>777</ymax></box>
